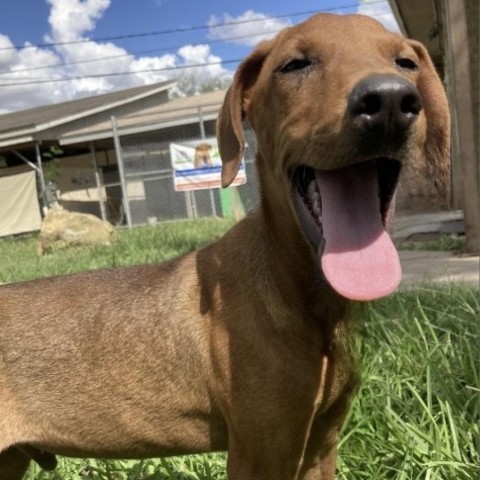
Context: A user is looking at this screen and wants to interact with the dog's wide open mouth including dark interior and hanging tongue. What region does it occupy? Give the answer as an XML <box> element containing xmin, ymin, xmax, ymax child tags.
<box><xmin>291</xmin><ymin>158</ymin><xmax>401</xmax><ymax>300</ymax></box>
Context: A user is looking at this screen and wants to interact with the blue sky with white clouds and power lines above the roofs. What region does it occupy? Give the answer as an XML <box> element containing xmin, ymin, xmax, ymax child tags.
<box><xmin>0</xmin><ymin>0</ymin><xmax>395</xmax><ymax>113</ymax></box>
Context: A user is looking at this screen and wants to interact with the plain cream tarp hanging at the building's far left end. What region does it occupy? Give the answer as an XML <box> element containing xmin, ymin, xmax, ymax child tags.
<box><xmin>0</xmin><ymin>171</ymin><xmax>42</xmax><ymax>237</ymax></box>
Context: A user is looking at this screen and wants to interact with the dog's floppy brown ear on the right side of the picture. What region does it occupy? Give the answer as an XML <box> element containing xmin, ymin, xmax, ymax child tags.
<box><xmin>408</xmin><ymin>40</ymin><xmax>450</xmax><ymax>196</ymax></box>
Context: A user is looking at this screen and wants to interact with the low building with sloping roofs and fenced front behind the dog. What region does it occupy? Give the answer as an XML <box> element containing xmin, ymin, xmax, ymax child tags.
<box><xmin>0</xmin><ymin>82</ymin><xmax>257</xmax><ymax>236</ymax></box>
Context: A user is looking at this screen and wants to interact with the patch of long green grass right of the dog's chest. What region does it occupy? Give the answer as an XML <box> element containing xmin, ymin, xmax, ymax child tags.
<box><xmin>339</xmin><ymin>286</ymin><xmax>480</xmax><ymax>480</ymax></box>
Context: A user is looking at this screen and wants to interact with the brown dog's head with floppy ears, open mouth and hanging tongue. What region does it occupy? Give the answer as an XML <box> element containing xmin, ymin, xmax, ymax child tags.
<box><xmin>217</xmin><ymin>14</ymin><xmax>450</xmax><ymax>299</ymax></box>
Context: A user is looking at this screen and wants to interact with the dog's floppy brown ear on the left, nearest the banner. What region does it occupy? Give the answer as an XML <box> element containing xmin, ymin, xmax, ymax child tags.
<box><xmin>217</xmin><ymin>40</ymin><xmax>273</xmax><ymax>188</ymax></box>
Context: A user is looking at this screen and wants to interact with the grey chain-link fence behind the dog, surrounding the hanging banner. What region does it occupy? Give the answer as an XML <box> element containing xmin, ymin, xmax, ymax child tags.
<box><xmin>109</xmin><ymin>117</ymin><xmax>259</xmax><ymax>225</ymax></box>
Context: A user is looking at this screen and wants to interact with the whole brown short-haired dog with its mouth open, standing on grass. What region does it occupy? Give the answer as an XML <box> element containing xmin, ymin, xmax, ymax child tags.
<box><xmin>0</xmin><ymin>15</ymin><xmax>449</xmax><ymax>480</ymax></box>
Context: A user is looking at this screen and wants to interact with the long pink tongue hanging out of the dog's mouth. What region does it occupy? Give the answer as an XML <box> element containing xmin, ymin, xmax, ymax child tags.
<box><xmin>317</xmin><ymin>164</ymin><xmax>402</xmax><ymax>300</ymax></box>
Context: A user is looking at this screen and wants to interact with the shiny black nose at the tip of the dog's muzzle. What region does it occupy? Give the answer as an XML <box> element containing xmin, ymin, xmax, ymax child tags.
<box><xmin>348</xmin><ymin>75</ymin><xmax>422</xmax><ymax>133</ymax></box>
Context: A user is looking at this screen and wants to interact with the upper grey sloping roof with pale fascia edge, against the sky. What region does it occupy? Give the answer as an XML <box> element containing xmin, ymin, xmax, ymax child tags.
<box><xmin>0</xmin><ymin>81</ymin><xmax>176</xmax><ymax>146</ymax></box>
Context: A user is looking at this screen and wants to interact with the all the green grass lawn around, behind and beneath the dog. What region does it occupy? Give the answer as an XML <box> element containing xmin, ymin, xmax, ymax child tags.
<box><xmin>0</xmin><ymin>220</ymin><xmax>480</xmax><ymax>480</ymax></box>
